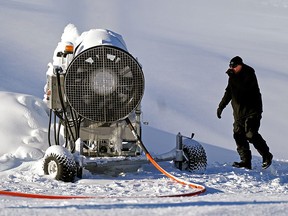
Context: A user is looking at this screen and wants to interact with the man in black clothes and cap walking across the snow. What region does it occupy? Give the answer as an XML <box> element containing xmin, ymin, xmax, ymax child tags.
<box><xmin>217</xmin><ymin>56</ymin><xmax>273</xmax><ymax>169</ymax></box>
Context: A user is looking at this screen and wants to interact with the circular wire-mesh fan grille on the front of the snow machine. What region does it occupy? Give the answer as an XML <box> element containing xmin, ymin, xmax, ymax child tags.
<box><xmin>65</xmin><ymin>46</ymin><xmax>144</xmax><ymax>122</ymax></box>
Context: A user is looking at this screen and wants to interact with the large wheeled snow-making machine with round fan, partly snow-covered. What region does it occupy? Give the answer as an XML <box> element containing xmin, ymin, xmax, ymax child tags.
<box><xmin>43</xmin><ymin>29</ymin><xmax>207</xmax><ymax>182</ymax></box>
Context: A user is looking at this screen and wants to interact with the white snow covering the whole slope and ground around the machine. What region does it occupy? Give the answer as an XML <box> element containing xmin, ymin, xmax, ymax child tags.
<box><xmin>0</xmin><ymin>0</ymin><xmax>288</xmax><ymax>216</ymax></box>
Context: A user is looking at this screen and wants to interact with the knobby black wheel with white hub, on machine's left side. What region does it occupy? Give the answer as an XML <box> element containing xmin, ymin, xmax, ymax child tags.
<box><xmin>43</xmin><ymin>153</ymin><xmax>77</xmax><ymax>182</ymax></box>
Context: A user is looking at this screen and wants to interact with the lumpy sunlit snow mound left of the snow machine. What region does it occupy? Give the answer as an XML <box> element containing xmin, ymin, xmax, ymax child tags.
<box><xmin>0</xmin><ymin>92</ymin><xmax>48</xmax><ymax>170</ymax></box>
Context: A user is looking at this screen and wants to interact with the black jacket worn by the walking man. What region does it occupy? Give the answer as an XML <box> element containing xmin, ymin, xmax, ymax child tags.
<box><xmin>219</xmin><ymin>64</ymin><xmax>263</xmax><ymax>120</ymax></box>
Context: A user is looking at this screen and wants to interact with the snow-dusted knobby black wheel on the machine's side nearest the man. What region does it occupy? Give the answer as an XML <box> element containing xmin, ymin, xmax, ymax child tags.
<box><xmin>183</xmin><ymin>141</ymin><xmax>207</xmax><ymax>172</ymax></box>
